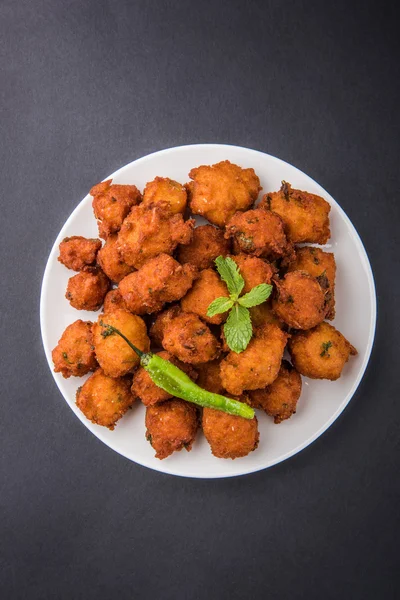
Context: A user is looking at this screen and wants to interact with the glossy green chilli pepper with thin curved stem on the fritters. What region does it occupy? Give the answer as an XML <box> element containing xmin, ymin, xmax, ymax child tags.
<box><xmin>103</xmin><ymin>323</ymin><xmax>254</xmax><ymax>419</ymax></box>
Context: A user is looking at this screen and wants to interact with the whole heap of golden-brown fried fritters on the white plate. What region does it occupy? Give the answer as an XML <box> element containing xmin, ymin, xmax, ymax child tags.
<box><xmin>53</xmin><ymin>161</ymin><xmax>356</xmax><ymax>459</ymax></box>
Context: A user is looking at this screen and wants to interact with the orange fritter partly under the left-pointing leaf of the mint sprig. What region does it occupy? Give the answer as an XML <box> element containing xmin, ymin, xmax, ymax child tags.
<box><xmin>181</xmin><ymin>269</ymin><xmax>229</xmax><ymax>325</ymax></box>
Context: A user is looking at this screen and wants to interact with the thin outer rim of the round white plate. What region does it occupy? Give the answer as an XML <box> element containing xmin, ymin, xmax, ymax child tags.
<box><xmin>39</xmin><ymin>143</ymin><xmax>377</xmax><ymax>479</ymax></box>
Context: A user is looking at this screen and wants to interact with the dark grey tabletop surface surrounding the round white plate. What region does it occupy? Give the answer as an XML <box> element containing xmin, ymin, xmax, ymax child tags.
<box><xmin>0</xmin><ymin>0</ymin><xmax>400</xmax><ymax>600</ymax></box>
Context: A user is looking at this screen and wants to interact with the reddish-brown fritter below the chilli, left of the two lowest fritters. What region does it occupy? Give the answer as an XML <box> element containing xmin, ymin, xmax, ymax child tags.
<box><xmin>146</xmin><ymin>398</ymin><xmax>199</xmax><ymax>460</ymax></box>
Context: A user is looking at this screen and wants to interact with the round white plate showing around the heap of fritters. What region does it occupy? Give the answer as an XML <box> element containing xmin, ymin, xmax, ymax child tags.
<box><xmin>40</xmin><ymin>144</ymin><xmax>376</xmax><ymax>478</ymax></box>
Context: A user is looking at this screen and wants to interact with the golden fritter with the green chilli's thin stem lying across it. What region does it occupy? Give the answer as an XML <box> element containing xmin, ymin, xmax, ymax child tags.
<box><xmin>93</xmin><ymin>310</ymin><xmax>150</xmax><ymax>377</ymax></box>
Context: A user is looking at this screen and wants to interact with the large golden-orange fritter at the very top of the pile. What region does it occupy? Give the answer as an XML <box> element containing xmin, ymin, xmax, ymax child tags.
<box><xmin>187</xmin><ymin>160</ymin><xmax>261</xmax><ymax>227</ymax></box>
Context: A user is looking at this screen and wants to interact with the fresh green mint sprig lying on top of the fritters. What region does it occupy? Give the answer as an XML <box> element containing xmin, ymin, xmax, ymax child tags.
<box><xmin>207</xmin><ymin>256</ymin><xmax>272</xmax><ymax>354</ymax></box>
